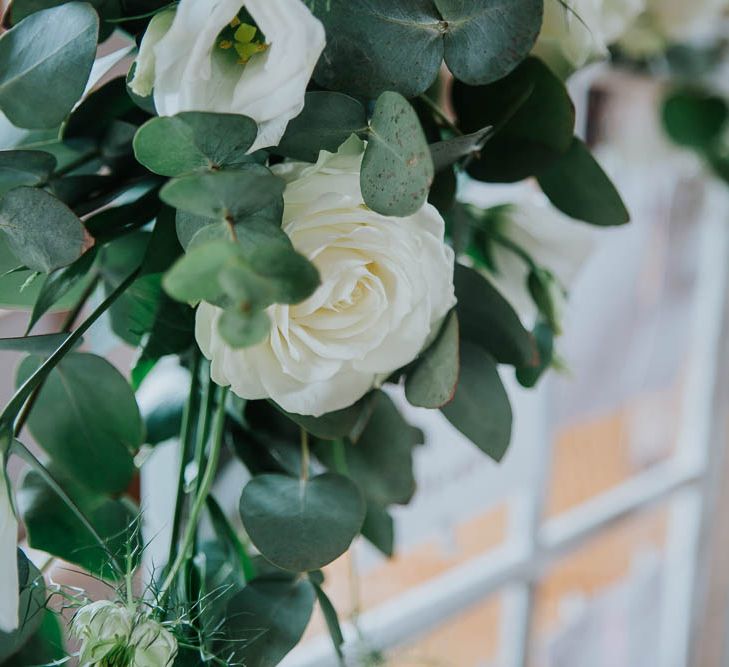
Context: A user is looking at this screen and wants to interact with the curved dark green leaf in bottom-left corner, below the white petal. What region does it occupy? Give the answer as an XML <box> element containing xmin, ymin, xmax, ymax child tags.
<box><xmin>0</xmin><ymin>549</ymin><xmax>46</xmax><ymax>667</ymax></box>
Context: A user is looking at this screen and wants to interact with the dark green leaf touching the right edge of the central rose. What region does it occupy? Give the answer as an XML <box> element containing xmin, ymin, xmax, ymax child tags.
<box><xmin>454</xmin><ymin>264</ymin><xmax>538</xmax><ymax>366</ymax></box>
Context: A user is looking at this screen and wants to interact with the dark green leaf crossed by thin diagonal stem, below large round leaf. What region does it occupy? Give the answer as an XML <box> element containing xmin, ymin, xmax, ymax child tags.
<box><xmin>18</xmin><ymin>471</ymin><xmax>139</xmax><ymax>579</ymax></box>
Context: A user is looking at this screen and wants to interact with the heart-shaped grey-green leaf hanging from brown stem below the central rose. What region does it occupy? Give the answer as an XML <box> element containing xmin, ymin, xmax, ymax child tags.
<box><xmin>240</xmin><ymin>473</ymin><xmax>366</xmax><ymax>572</ymax></box>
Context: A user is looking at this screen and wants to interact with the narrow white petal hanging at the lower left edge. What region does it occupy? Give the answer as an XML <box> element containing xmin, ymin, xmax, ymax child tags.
<box><xmin>0</xmin><ymin>454</ymin><xmax>19</xmax><ymax>632</ymax></box>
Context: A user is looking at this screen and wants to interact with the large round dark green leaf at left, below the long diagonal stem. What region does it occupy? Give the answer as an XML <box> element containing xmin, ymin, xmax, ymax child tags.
<box><xmin>18</xmin><ymin>353</ymin><xmax>144</xmax><ymax>493</ymax></box>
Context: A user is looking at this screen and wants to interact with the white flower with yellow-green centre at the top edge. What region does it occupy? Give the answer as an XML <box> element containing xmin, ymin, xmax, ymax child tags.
<box><xmin>132</xmin><ymin>0</ymin><xmax>326</xmax><ymax>151</ymax></box>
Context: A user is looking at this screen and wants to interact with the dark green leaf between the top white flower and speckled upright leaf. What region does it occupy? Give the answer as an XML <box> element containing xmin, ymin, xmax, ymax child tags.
<box><xmin>273</xmin><ymin>91</ymin><xmax>367</xmax><ymax>162</ymax></box>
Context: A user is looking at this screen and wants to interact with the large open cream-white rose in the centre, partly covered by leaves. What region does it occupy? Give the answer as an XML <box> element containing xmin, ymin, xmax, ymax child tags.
<box><xmin>196</xmin><ymin>138</ymin><xmax>455</xmax><ymax>415</ymax></box>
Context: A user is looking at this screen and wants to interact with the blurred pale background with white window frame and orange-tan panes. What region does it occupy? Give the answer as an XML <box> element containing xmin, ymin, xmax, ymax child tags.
<box><xmin>0</xmin><ymin>0</ymin><xmax>729</xmax><ymax>667</ymax></box>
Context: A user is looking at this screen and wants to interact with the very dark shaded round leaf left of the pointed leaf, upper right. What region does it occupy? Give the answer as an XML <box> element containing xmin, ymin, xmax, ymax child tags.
<box><xmin>453</xmin><ymin>58</ymin><xmax>575</xmax><ymax>182</ymax></box>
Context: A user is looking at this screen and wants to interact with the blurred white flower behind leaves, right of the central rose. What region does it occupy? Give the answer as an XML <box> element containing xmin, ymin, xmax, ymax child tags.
<box><xmin>462</xmin><ymin>182</ymin><xmax>595</xmax><ymax>326</ymax></box>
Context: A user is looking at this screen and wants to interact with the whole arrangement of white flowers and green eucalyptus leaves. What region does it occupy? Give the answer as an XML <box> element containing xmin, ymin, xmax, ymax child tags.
<box><xmin>0</xmin><ymin>0</ymin><xmax>700</xmax><ymax>667</ymax></box>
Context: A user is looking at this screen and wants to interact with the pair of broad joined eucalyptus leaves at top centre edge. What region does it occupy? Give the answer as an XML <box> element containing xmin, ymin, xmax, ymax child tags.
<box><xmin>315</xmin><ymin>0</ymin><xmax>543</xmax><ymax>98</ymax></box>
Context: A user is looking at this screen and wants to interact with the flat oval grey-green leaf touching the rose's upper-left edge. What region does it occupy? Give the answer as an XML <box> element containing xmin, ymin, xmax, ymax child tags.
<box><xmin>160</xmin><ymin>165</ymin><xmax>285</xmax><ymax>221</ymax></box>
